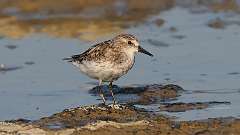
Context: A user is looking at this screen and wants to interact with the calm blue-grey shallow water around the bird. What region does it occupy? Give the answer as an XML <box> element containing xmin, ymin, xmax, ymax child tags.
<box><xmin>0</xmin><ymin>7</ymin><xmax>240</xmax><ymax>120</ymax></box>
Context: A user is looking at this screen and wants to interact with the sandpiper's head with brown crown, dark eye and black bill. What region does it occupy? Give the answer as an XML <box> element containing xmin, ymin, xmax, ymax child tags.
<box><xmin>113</xmin><ymin>34</ymin><xmax>153</xmax><ymax>56</ymax></box>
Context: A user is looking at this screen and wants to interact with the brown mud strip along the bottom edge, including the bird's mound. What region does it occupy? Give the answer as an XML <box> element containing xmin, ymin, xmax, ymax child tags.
<box><xmin>0</xmin><ymin>105</ymin><xmax>240</xmax><ymax>135</ymax></box>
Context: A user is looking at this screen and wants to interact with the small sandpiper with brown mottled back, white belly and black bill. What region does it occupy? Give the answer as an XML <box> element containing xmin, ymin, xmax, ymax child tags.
<box><xmin>63</xmin><ymin>34</ymin><xmax>153</xmax><ymax>104</ymax></box>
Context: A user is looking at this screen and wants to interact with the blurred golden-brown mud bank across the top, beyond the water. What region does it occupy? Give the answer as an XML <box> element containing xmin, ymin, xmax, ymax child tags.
<box><xmin>0</xmin><ymin>0</ymin><xmax>239</xmax><ymax>40</ymax></box>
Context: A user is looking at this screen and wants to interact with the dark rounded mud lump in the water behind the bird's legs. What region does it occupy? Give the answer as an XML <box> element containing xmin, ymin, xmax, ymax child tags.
<box><xmin>89</xmin><ymin>84</ymin><xmax>184</xmax><ymax>105</ymax></box>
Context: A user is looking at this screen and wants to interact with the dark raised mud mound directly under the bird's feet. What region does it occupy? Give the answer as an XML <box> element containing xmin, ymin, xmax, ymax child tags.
<box><xmin>33</xmin><ymin>104</ymin><xmax>147</xmax><ymax>129</ymax></box>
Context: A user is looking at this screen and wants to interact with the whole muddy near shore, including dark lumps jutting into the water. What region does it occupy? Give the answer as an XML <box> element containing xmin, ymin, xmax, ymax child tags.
<box><xmin>0</xmin><ymin>84</ymin><xmax>240</xmax><ymax>135</ymax></box>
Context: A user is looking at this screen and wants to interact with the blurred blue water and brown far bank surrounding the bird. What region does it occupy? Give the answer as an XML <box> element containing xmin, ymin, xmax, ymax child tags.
<box><xmin>0</xmin><ymin>0</ymin><xmax>240</xmax><ymax>120</ymax></box>
